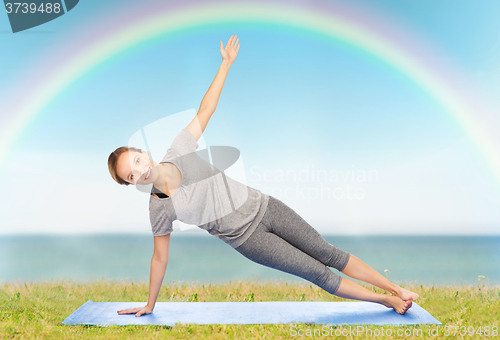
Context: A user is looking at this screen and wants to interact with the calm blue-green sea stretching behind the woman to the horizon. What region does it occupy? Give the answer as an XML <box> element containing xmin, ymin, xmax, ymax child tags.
<box><xmin>0</xmin><ymin>231</ymin><xmax>500</xmax><ymax>286</ymax></box>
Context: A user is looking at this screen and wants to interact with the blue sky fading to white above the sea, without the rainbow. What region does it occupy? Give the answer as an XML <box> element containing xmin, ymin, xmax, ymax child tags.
<box><xmin>0</xmin><ymin>0</ymin><xmax>500</xmax><ymax>235</ymax></box>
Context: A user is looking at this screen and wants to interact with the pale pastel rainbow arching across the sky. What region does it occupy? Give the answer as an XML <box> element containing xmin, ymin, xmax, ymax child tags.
<box><xmin>0</xmin><ymin>1</ymin><xmax>500</xmax><ymax>191</ymax></box>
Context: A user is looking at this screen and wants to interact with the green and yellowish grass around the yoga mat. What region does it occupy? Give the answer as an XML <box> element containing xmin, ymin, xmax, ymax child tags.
<box><xmin>0</xmin><ymin>281</ymin><xmax>500</xmax><ymax>339</ymax></box>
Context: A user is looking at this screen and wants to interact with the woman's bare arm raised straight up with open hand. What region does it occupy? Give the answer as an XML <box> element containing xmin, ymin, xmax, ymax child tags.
<box><xmin>186</xmin><ymin>35</ymin><xmax>241</xmax><ymax>141</ymax></box>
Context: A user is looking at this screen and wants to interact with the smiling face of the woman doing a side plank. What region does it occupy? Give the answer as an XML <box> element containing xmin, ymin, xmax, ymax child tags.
<box><xmin>116</xmin><ymin>151</ymin><xmax>158</xmax><ymax>185</ymax></box>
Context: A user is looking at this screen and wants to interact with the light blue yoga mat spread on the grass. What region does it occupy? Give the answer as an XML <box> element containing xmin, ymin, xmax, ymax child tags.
<box><xmin>62</xmin><ymin>300</ymin><xmax>441</xmax><ymax>326</ymax></box>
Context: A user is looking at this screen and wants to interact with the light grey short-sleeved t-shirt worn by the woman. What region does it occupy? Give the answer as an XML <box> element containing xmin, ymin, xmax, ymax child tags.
<box><xmin>149</xmin><ymin>129</ymin><xmax>269</xmax><ymax>248</ymax></box>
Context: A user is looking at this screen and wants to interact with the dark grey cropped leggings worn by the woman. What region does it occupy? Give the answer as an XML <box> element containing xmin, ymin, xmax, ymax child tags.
<box><xmin>235</xmin><ymin>196</ymin><xmax>350</xmax><ymax>294</ymax></box>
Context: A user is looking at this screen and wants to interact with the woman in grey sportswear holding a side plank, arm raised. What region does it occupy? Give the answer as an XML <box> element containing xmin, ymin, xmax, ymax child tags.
<box><xmin>108</xmin><ymin>36</ymin><xmax>418</xmax><ymax>316</ymax></box>
